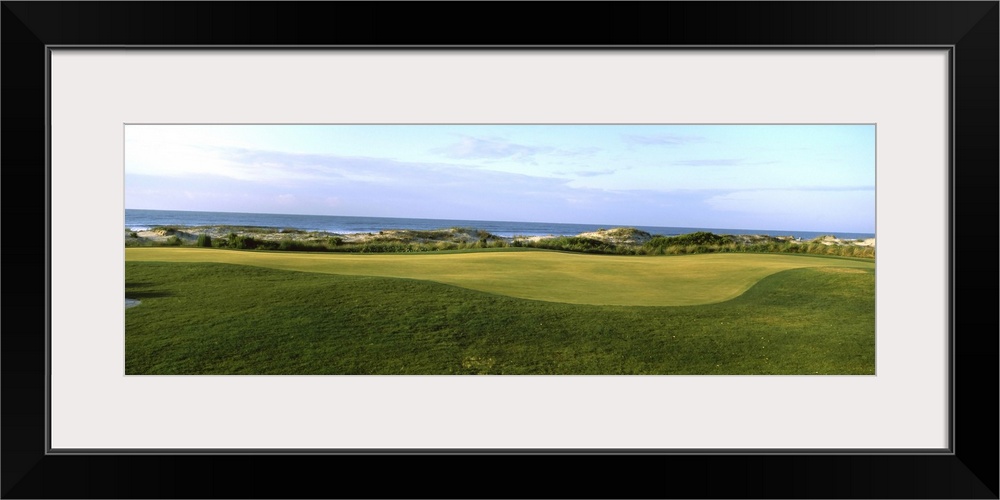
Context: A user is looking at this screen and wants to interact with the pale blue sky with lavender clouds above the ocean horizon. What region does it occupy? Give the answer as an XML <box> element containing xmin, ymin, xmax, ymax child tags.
<box><xmin>124</xmin><ymin>124</ymin><xmax>875</xmax><ymax>233</ymax></box>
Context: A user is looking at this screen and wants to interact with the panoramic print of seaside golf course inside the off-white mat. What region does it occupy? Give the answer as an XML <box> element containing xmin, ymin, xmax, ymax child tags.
<box><xmin>123</xmin><ymin>124</ymin><xmax>876</xmax><ymax>375</ymax></box>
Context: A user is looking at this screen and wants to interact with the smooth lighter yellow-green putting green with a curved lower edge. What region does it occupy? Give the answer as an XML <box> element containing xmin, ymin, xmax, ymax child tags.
<box><xmin>125</xmin><ymin>247</ymin><xmax>875</xmax><ymax>306</ymax></box>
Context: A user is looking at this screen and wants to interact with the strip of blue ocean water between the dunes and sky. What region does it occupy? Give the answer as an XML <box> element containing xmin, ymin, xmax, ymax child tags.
<box><xmin>125</xmin><ymin>209</ymin><xmax>875</xmax><ymax>239</ymax></box>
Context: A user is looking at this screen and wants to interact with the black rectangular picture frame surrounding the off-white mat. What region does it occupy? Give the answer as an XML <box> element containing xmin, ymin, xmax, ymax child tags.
<box><xmin>0</xmin><ymin>1</ymin><xmax>1000</xmax><ymax>498</ymax></box>
